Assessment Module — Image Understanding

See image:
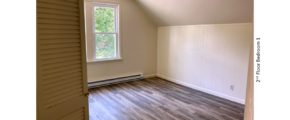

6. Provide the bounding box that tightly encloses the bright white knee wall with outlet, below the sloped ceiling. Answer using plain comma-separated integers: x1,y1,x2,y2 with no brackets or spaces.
157,23,253,104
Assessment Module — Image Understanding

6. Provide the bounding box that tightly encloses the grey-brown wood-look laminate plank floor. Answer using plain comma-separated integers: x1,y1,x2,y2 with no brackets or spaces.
89,78,244,120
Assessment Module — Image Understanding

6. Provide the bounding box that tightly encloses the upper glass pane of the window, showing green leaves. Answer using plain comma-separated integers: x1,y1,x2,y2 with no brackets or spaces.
95,7,115,32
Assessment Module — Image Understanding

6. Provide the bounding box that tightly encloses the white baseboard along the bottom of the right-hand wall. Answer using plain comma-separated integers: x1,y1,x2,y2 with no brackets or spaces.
156,74,245,105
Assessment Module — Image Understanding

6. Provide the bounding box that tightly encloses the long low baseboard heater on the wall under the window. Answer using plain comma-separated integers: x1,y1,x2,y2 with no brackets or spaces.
88,74,144,89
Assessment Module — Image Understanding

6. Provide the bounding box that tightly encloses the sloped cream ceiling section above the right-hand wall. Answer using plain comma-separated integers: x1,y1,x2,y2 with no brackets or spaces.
136,0,253,26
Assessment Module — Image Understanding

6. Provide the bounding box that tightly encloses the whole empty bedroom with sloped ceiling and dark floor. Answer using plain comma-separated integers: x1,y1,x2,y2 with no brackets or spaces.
37,0,253,120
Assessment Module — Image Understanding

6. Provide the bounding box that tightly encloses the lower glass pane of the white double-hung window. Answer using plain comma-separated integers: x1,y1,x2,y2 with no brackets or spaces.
96,34,117,59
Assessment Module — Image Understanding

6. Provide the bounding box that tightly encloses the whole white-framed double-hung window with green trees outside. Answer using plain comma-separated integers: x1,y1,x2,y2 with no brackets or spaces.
86,3,121,62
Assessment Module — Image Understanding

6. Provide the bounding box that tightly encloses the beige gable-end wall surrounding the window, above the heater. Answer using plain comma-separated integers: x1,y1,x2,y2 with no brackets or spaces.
87,0,157,82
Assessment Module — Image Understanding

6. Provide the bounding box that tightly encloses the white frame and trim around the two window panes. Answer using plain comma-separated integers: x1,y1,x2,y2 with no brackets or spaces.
86,2,122,62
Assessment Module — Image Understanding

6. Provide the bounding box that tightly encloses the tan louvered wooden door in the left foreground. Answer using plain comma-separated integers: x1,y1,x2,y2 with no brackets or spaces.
36,0,88,120
